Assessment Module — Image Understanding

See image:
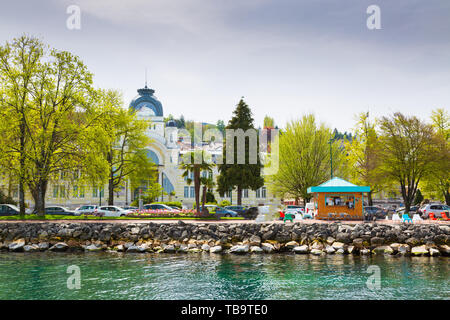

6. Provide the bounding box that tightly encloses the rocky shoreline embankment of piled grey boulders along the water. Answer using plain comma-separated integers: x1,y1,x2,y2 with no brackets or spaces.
0,221,450,256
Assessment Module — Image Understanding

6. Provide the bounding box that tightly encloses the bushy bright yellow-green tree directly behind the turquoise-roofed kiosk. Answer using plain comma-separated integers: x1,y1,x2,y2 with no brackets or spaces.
268,114,347,201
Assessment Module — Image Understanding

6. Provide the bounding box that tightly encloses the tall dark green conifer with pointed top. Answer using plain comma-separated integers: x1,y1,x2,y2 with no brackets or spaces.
217,98,264,205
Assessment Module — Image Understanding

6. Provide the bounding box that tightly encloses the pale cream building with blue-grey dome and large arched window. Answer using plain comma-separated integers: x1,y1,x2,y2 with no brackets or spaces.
15,84,279,209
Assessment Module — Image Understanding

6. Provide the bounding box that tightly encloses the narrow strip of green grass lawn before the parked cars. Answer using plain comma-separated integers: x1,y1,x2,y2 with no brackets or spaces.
0,214,244,221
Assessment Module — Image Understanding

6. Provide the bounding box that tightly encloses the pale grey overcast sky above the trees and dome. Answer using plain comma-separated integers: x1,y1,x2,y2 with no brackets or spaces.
0,0,450,131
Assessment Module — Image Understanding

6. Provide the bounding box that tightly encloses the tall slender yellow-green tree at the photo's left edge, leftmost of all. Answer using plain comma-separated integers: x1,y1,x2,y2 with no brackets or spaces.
0,36,44,216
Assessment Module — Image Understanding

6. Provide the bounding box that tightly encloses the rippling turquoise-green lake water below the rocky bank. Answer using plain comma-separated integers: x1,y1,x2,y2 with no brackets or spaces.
0,253,450,300
